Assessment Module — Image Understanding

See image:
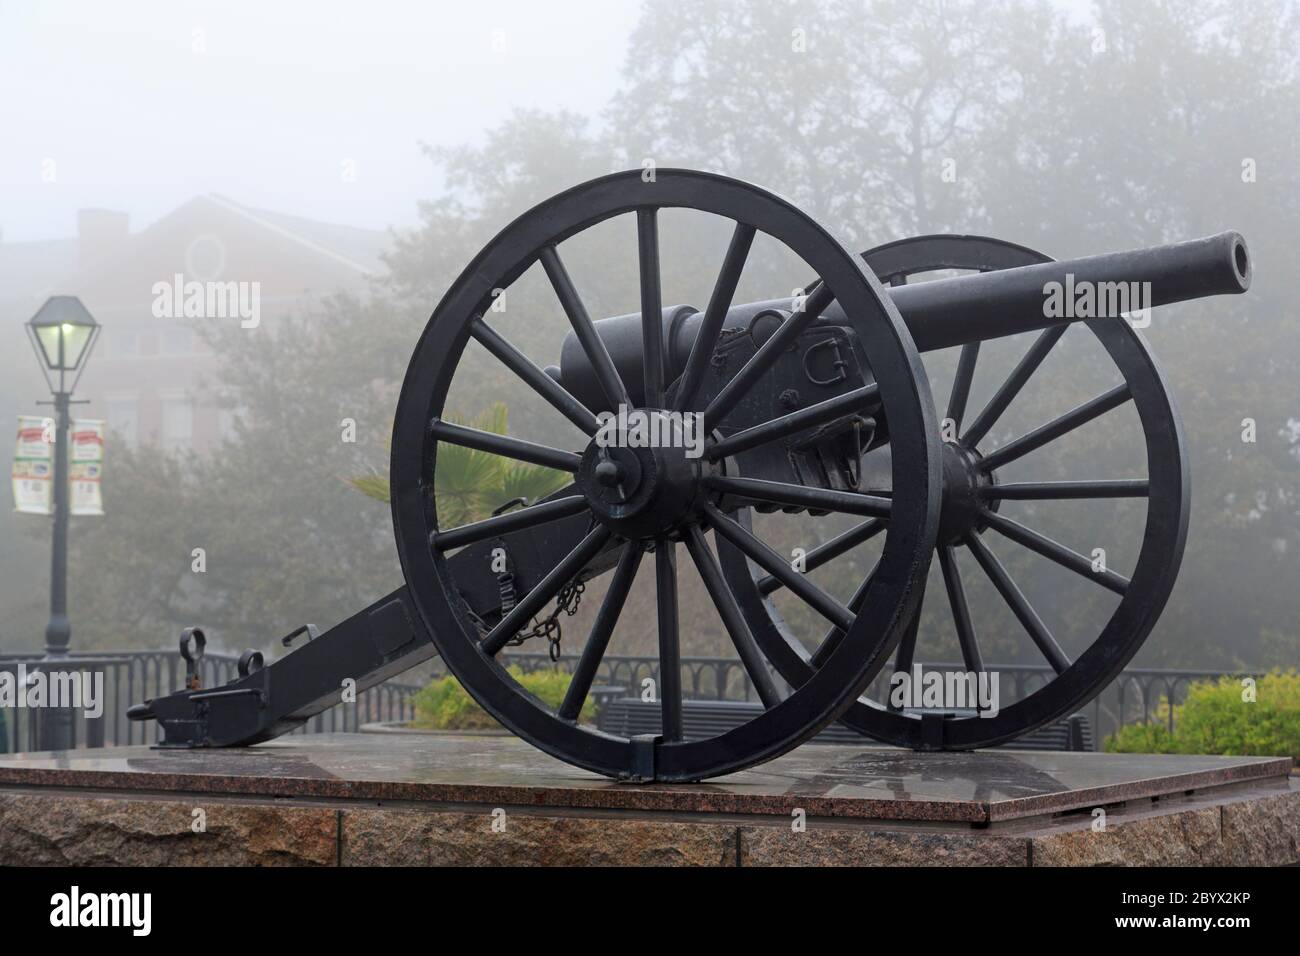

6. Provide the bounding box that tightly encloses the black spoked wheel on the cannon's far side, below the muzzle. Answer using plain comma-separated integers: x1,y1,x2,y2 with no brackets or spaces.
719,235,1190,750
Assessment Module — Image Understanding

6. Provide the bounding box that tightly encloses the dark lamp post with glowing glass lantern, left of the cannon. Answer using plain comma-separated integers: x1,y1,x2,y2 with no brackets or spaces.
27,295,100,750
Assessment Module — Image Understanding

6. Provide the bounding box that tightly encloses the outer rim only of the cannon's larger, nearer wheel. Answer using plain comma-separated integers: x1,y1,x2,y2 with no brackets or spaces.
390,169,939,780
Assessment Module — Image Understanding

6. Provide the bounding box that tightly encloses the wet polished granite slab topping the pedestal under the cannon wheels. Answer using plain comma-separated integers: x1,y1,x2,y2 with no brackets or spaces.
0,734,1291,823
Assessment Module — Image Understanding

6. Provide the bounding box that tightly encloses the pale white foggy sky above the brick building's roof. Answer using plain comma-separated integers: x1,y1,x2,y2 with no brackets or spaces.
0,0,640,242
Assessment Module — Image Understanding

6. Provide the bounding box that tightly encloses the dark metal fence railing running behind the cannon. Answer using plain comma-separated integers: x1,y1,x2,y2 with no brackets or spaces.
0,650,1255,753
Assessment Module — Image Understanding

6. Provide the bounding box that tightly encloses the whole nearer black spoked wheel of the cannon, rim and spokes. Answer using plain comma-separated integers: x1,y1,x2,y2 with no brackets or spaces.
390,169,940,780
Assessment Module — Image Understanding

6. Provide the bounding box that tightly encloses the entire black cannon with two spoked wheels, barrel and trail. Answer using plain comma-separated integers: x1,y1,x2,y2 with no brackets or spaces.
129,169,1251,780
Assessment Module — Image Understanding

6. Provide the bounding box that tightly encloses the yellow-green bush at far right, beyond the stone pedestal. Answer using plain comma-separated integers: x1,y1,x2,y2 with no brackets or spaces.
1106,670,1300,761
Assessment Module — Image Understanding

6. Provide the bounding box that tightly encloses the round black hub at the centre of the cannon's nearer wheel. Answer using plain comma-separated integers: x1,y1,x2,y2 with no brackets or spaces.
575,408,718,538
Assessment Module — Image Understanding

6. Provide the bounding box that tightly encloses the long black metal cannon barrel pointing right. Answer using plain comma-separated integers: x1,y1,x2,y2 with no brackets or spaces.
553,232,1251,408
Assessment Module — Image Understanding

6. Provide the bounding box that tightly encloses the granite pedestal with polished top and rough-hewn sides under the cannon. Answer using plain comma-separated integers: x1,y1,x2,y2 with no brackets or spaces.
0,734,1300,866
